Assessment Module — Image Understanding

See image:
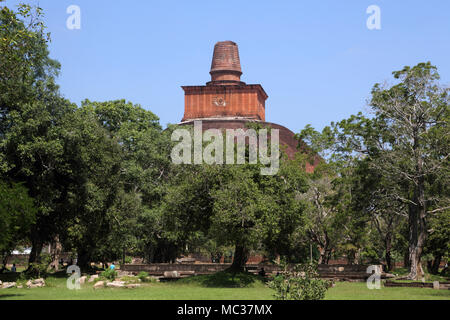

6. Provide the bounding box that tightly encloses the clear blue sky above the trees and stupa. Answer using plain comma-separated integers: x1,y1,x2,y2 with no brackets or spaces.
6,0,450,132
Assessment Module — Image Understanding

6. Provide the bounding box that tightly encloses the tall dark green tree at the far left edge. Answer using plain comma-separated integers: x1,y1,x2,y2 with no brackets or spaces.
0,1,75,263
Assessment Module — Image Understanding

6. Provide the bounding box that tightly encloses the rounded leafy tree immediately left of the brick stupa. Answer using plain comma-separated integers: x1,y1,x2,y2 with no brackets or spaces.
64,100,174,268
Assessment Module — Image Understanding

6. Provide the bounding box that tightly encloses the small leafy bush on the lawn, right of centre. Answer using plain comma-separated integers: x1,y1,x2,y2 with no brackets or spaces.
269,264,329,300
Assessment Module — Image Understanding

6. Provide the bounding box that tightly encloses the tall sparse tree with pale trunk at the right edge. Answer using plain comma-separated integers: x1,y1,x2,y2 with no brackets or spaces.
358,63,450,279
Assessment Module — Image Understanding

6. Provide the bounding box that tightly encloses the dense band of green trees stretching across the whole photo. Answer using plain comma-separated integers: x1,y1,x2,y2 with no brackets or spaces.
0,1,450,282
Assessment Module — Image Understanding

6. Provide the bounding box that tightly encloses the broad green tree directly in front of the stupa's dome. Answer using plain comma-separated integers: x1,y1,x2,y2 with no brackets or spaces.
163,144,306,271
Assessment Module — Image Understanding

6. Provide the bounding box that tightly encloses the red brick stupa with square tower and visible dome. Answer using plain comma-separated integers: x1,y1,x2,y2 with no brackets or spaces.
180,41,317,172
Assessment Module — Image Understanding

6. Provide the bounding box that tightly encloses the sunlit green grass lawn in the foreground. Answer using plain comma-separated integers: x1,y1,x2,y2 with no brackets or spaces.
0,273,450,300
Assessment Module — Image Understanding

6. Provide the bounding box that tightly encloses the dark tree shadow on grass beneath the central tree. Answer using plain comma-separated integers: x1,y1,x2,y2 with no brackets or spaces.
177,271,262,288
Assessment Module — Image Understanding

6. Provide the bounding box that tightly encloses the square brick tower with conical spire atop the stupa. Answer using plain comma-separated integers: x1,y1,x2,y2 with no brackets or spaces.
182,41,268,122
